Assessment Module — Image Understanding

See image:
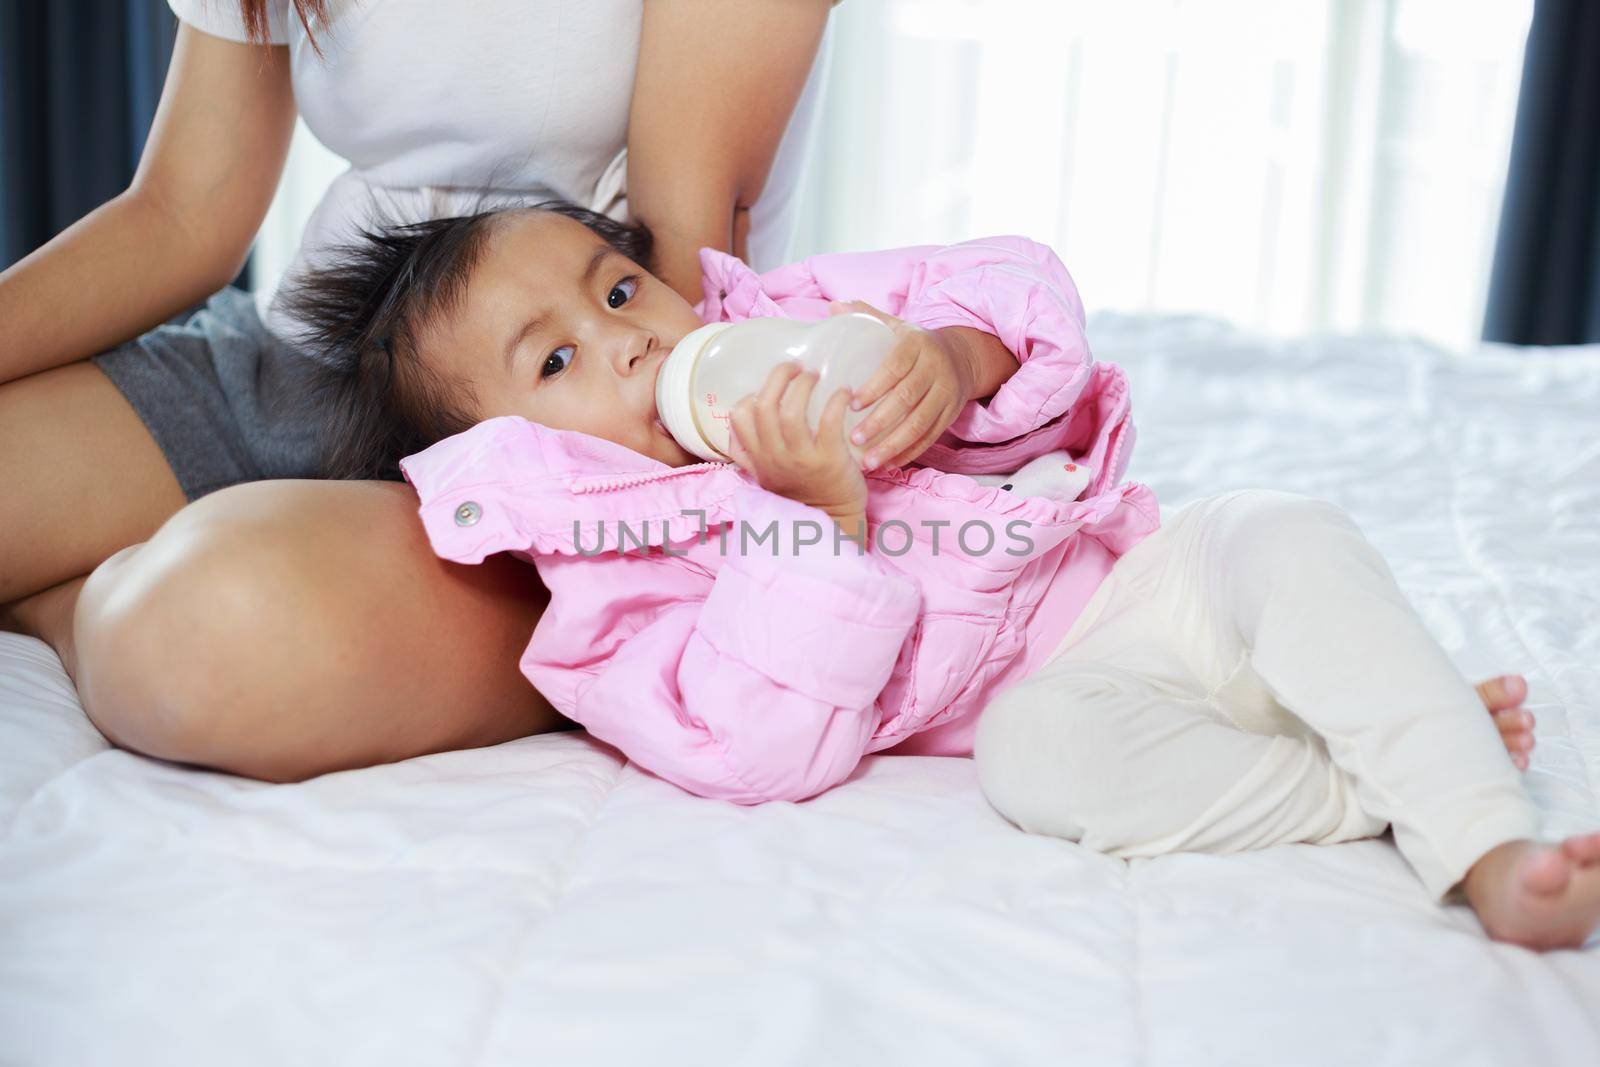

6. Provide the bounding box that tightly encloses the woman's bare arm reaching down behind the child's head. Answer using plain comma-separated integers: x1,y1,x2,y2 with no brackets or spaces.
627,0,834,302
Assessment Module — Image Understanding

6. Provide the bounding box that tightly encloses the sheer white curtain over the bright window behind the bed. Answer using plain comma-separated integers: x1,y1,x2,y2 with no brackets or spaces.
797,0,1531,346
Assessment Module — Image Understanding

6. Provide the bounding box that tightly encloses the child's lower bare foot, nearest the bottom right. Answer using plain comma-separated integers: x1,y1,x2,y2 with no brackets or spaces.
1462,833,1600,949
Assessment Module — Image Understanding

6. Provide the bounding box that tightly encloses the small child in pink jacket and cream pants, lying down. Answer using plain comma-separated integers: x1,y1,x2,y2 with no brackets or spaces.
293,202,1600,947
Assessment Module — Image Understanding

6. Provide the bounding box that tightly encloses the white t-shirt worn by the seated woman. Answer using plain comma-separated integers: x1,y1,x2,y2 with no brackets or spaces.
168,0,830,334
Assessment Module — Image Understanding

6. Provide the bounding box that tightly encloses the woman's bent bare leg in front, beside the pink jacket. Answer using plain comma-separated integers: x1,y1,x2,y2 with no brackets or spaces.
75,482,570,781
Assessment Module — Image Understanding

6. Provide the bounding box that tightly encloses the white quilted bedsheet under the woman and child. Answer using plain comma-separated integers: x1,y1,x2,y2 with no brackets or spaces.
0,315,1600,1067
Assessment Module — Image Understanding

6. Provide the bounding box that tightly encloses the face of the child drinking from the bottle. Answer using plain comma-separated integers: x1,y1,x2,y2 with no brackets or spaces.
422,211,701,467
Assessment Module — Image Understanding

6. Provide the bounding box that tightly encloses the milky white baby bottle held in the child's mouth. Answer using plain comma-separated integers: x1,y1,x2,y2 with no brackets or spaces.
656,312,894,461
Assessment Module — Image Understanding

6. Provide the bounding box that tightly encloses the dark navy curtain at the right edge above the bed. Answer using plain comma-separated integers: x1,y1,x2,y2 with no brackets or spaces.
1483,0,1600,344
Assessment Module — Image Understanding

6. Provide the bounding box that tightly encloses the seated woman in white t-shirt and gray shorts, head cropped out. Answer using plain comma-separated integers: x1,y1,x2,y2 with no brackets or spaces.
0,0,832,781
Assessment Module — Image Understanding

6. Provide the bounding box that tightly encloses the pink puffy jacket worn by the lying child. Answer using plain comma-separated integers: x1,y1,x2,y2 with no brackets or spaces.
402,237,1158,803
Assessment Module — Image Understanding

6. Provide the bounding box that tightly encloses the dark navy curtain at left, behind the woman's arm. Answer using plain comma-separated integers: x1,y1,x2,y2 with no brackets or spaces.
0,0,178,269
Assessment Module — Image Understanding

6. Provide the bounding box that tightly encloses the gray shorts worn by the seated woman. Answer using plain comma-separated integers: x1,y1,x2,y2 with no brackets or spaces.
93,288,320,501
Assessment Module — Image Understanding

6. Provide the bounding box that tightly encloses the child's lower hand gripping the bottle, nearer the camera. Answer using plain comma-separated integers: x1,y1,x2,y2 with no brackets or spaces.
728,362,867,537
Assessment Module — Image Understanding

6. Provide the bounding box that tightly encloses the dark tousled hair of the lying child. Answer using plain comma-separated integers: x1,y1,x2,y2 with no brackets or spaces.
283,200,654,482
